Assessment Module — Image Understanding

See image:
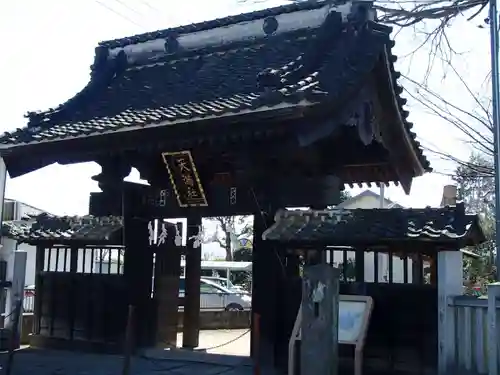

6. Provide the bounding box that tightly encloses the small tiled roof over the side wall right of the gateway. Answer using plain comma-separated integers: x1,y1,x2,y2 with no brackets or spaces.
263,204,484,246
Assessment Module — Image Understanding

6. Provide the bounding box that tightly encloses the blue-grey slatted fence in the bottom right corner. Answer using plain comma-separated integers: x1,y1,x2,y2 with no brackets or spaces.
447,285,500,375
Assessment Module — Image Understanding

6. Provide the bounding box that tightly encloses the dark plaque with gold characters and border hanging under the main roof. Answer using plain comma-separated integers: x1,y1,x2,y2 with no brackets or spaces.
162,151,208,207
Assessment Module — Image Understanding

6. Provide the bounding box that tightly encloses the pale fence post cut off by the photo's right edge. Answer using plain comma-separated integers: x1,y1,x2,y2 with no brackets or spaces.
487,282,500,375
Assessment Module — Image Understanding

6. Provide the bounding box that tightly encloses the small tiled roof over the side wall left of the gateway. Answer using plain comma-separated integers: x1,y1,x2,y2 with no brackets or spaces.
2,213,123,244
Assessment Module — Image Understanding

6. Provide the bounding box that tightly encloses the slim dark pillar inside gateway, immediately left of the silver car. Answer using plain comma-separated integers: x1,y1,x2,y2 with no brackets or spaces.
182,216,202,349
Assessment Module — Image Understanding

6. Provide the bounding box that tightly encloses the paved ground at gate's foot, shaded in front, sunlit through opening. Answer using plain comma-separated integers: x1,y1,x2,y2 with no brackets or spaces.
0,330,260,375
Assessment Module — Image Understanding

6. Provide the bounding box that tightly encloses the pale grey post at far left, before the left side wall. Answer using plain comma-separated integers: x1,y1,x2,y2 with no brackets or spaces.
5,251,28,346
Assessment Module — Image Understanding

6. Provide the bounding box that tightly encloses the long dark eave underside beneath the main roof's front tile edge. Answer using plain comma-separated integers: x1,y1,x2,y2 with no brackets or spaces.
0,108,302,177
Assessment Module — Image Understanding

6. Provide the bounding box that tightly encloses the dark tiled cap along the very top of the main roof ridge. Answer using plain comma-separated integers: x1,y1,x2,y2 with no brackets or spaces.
99,0,330,48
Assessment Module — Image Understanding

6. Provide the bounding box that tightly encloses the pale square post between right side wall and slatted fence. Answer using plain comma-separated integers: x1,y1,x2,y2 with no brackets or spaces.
437,250,463,375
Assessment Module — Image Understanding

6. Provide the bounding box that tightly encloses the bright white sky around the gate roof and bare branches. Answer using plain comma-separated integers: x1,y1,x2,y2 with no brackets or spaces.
0,0,490,215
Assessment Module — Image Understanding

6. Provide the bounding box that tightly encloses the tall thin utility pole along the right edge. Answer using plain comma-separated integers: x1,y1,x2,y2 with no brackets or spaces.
490,0,500,280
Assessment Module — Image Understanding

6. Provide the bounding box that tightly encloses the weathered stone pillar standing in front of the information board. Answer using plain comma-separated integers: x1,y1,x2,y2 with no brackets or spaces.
300,264,339,375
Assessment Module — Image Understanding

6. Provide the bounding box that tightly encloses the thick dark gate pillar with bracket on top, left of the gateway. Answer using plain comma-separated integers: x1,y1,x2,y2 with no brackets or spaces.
89,159,156,347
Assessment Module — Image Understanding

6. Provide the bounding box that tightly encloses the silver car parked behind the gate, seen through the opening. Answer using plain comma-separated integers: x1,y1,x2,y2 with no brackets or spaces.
179,278,252,311
